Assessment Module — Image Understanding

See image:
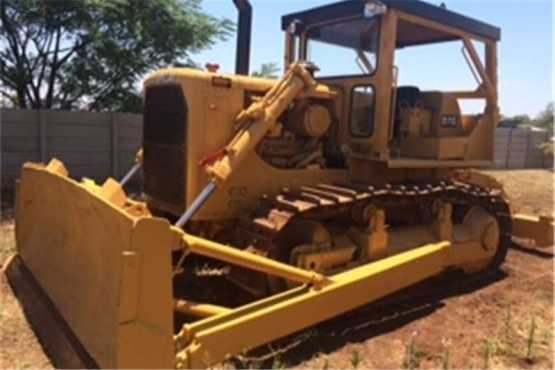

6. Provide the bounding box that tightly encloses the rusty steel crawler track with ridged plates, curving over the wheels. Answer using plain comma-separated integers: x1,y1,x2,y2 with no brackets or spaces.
239,180,511,265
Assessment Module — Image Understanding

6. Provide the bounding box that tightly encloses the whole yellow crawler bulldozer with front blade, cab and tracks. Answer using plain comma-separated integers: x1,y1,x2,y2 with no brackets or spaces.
4,0,553,368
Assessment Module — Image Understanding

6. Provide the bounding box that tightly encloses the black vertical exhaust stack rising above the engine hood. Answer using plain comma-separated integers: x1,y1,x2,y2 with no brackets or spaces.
233,0,252,75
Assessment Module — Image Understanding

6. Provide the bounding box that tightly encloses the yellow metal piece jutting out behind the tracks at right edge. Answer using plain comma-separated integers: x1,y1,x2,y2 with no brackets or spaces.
512,214,553,248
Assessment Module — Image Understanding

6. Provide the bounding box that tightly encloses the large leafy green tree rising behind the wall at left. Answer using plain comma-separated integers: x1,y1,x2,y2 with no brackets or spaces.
0,0,233,111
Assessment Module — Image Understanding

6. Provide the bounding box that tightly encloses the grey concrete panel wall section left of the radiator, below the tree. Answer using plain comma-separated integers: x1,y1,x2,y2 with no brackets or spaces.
0,109,142,189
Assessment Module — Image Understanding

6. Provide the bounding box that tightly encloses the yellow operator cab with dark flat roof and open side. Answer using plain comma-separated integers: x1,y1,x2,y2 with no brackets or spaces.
282,0,500,168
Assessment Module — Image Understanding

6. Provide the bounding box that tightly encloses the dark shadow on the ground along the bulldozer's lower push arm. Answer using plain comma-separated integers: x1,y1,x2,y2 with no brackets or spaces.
238,270,508,368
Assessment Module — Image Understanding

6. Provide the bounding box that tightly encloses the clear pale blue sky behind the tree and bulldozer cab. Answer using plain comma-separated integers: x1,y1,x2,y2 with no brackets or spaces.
193,0,554,116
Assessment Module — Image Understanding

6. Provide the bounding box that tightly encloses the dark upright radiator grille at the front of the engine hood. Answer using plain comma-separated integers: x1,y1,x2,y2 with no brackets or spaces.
143,84,187,206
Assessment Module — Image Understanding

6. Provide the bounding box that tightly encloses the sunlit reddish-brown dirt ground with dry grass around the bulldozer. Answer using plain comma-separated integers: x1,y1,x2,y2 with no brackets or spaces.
0,170,553,369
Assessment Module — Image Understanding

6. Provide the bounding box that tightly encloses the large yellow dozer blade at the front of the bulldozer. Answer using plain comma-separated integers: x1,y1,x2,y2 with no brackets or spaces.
2,160,180,368
